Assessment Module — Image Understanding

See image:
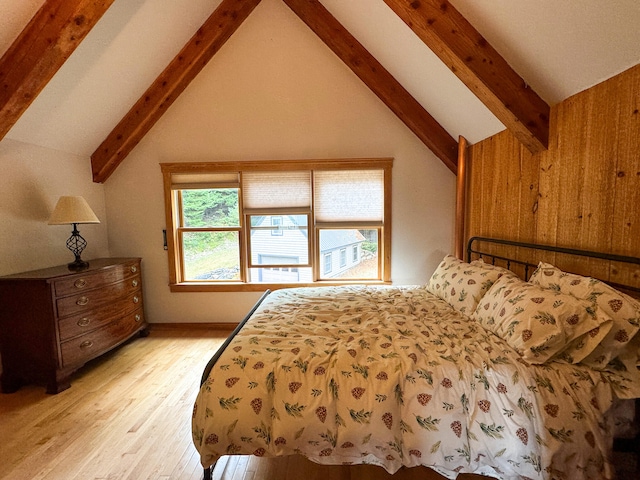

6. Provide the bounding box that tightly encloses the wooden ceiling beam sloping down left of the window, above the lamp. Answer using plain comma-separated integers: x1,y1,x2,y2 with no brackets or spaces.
91,0,260,182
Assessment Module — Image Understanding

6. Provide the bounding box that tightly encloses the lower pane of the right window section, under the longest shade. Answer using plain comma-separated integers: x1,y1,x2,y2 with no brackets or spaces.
320,229,379,280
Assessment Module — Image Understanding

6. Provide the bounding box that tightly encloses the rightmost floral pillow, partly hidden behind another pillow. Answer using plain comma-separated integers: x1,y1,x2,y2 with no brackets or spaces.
529,262,640,370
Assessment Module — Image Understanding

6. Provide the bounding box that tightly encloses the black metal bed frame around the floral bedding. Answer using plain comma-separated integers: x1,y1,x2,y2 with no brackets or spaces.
200,237,640,480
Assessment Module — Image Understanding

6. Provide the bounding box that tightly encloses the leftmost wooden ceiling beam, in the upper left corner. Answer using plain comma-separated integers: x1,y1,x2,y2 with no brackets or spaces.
0,0,113,140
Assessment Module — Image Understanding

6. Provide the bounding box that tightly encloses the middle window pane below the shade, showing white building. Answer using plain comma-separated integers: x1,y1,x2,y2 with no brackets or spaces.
249,215,309,265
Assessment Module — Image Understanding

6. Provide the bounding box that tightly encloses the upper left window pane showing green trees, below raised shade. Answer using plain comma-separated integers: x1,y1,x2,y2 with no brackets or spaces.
180,188,240,228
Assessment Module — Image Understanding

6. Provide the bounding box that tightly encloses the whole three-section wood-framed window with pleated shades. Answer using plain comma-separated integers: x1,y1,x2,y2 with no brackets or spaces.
161,159,392,291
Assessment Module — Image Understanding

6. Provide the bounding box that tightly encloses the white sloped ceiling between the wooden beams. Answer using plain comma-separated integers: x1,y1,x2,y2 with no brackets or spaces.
0,0,640,157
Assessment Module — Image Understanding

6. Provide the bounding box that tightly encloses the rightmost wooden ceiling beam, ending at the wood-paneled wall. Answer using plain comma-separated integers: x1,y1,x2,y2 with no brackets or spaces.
384,0,550,153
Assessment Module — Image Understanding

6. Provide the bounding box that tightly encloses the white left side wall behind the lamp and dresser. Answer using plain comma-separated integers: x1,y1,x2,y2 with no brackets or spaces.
0,138,109,275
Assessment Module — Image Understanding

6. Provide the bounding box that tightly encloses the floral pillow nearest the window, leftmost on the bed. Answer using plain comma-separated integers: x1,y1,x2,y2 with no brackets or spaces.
426,255,514,316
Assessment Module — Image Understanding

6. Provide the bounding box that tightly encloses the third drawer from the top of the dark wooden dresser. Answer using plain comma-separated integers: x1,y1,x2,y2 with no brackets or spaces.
59,291,142,342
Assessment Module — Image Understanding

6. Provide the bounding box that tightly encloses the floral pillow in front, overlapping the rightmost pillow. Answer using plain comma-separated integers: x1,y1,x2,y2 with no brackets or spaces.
473,276,610,364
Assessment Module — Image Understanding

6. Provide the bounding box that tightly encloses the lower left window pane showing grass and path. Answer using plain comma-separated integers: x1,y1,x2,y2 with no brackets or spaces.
182,232,240,281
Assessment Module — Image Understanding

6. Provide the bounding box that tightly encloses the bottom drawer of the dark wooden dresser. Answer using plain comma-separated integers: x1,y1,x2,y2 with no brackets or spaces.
60,309,144,367
